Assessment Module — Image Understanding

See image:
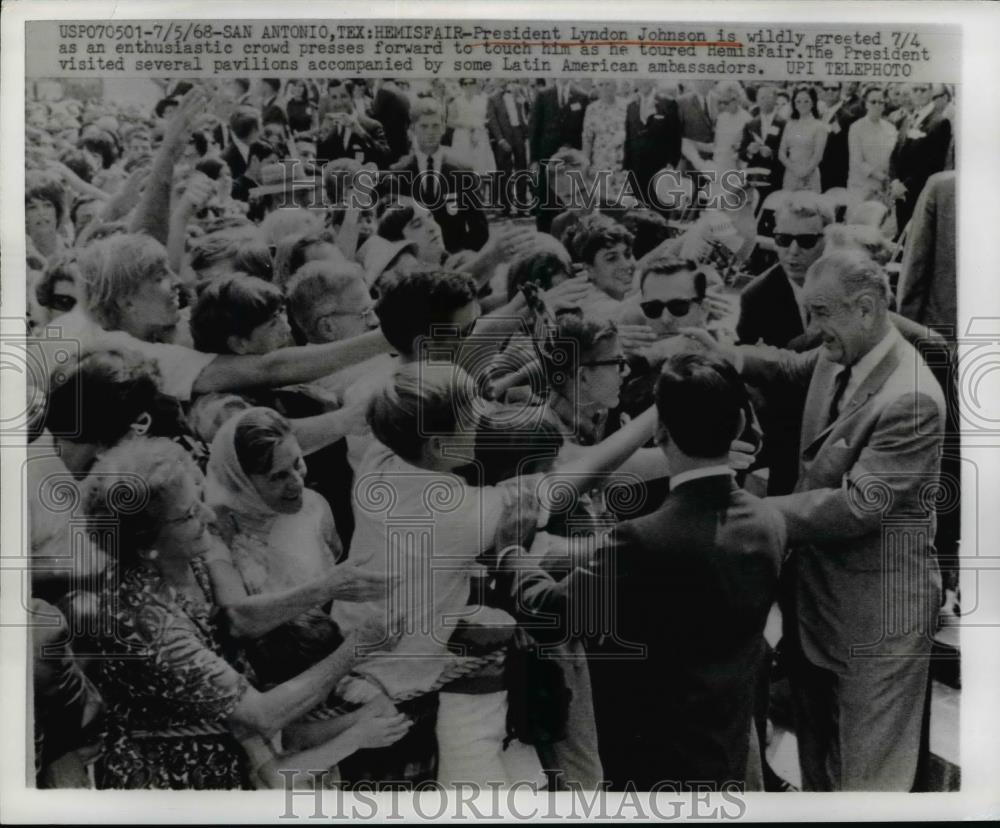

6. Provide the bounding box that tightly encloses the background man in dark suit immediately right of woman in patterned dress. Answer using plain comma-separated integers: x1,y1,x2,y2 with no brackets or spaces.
624,78,681,204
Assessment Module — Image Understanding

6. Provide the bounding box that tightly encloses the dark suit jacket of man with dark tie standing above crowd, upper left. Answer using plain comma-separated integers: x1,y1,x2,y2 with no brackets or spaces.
389,151,490,253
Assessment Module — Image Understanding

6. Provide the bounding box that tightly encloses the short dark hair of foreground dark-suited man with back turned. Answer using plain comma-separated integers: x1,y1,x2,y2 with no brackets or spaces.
655,354,749,458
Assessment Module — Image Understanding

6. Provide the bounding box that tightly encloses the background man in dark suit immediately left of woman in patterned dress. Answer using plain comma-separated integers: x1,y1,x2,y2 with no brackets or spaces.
528,79,590,233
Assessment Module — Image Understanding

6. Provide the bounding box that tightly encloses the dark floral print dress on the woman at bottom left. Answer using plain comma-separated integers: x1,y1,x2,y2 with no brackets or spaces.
95,561,253,790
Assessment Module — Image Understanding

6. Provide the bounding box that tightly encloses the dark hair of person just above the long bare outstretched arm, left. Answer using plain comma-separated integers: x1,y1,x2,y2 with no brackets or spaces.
191,273,285,354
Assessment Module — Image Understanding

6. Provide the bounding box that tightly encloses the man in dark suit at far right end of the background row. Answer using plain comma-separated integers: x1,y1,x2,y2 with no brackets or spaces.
889,83,951,232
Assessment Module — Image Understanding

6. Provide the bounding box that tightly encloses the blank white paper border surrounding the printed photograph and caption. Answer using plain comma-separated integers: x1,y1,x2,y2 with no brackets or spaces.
0,0,1000,824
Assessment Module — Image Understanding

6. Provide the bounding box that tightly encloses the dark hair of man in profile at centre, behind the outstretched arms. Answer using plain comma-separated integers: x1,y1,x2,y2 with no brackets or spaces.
375,270,477,355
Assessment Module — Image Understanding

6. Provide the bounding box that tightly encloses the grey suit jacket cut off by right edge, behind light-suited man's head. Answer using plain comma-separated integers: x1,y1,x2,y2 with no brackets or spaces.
896,171,958,339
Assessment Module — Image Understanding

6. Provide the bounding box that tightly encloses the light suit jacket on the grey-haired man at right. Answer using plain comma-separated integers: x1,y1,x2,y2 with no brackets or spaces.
742,334,945,675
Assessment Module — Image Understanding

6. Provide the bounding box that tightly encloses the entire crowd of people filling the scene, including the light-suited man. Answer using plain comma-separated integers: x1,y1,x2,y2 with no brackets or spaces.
25,78,957,791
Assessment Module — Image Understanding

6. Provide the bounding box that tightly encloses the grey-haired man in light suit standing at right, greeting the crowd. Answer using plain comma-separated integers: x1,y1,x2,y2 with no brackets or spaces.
706,251,945,791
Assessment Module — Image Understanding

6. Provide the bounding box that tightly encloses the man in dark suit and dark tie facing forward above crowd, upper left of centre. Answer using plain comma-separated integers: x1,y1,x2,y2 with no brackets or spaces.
389,98,489,253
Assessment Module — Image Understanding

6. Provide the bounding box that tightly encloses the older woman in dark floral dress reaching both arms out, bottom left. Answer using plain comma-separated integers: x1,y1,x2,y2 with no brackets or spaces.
83,439,406,789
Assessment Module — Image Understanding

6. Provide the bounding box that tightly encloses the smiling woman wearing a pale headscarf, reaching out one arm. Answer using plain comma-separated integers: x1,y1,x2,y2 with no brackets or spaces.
207,408,387,684
